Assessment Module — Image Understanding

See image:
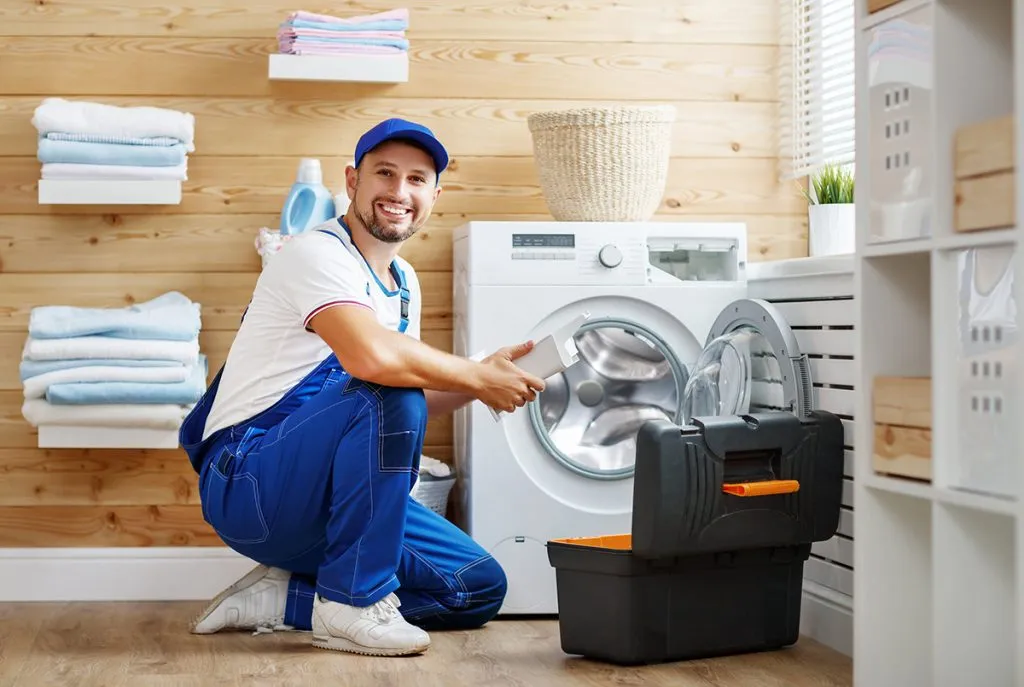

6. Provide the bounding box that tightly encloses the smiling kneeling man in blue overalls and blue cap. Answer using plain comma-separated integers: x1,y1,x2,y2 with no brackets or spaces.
180,119,544,655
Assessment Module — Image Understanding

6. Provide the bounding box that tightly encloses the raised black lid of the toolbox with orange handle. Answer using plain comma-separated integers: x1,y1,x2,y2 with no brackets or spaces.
632,411,844,558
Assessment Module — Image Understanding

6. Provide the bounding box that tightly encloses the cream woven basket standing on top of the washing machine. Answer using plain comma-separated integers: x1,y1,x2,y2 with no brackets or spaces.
526,105,676,222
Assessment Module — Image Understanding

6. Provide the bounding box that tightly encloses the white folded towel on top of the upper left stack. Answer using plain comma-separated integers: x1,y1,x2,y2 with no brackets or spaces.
32,98,196,153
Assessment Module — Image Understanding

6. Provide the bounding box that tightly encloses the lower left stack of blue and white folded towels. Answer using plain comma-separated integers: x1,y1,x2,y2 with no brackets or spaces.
19,292,209,436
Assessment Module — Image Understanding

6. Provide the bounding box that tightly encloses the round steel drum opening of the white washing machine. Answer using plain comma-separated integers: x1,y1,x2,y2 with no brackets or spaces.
529,317,687,479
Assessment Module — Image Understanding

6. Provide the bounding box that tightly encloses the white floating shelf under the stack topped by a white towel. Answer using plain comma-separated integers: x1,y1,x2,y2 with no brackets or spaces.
39,179,181,205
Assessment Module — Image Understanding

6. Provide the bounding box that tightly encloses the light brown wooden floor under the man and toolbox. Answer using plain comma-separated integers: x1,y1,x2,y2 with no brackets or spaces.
0,602,852,687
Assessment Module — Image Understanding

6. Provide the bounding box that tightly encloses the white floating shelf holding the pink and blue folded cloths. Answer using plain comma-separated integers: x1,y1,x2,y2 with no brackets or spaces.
269,52,409,84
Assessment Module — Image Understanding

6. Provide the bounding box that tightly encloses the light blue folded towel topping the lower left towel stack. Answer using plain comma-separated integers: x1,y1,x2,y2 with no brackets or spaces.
29,291,202,341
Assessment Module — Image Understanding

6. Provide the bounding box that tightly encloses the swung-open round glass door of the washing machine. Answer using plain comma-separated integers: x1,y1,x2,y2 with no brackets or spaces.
682,299,811,424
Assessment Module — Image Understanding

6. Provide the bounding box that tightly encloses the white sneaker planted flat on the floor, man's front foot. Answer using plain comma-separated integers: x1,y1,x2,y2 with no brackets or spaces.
313,594,430,656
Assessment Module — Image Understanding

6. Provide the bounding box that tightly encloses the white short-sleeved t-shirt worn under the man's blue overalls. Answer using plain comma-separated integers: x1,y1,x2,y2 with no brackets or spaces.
203,219,422,438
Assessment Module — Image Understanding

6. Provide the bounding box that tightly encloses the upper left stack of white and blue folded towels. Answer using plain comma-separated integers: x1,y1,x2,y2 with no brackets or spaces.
32,98,196,181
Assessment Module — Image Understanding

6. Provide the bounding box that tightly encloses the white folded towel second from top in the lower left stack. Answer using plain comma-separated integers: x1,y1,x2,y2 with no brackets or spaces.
22,336,199,366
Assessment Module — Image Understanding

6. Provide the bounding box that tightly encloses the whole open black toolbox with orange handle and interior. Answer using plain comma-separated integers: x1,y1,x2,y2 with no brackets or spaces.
547,411,844,664
